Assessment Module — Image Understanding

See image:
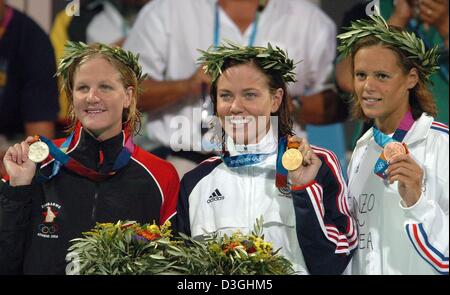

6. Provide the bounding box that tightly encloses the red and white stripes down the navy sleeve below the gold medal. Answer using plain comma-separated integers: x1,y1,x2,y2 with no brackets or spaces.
313,146,357,247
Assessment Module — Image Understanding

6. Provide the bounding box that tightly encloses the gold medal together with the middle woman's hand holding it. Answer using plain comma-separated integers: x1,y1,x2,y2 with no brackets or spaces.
281,136,322,186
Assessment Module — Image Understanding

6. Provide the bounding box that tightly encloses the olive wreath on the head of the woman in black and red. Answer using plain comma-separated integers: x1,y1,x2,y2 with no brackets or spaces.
56,41,147,83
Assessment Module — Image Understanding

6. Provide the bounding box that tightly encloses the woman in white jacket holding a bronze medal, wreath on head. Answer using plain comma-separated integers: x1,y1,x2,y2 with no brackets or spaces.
338,16,449,274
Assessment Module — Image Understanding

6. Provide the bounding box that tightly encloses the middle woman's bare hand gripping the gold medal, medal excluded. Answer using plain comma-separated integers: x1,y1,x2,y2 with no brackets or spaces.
289,136,322,186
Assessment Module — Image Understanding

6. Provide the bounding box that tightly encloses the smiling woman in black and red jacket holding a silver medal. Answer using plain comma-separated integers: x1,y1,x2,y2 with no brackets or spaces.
0,42,179,274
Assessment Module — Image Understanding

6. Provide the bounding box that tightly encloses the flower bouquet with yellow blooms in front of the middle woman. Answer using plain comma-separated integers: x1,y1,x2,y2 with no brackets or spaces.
168,218,294,275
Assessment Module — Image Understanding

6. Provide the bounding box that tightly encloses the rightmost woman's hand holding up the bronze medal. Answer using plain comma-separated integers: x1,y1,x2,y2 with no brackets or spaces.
386,154,423,207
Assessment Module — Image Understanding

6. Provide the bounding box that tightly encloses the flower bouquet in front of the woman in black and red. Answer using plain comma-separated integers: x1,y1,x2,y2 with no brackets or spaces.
66,221,178,275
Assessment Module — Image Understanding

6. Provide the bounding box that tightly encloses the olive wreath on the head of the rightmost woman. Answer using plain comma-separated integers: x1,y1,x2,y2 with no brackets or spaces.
337,14,439,81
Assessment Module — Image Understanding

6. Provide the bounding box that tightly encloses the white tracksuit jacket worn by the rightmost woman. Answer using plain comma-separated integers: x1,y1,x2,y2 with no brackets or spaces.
348,114,449,275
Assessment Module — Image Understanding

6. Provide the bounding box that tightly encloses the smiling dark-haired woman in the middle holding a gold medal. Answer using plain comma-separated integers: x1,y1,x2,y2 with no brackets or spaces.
177,43,357,274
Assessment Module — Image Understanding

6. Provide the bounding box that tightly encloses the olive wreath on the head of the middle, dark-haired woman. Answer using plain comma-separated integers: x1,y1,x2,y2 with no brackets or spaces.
198,42,296,83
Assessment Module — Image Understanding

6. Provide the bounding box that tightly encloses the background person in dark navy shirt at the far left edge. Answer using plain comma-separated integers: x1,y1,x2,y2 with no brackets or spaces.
0,0,58,176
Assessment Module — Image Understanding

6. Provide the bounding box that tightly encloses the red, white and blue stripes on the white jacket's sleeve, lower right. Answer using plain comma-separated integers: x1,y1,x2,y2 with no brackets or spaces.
405,224,448,275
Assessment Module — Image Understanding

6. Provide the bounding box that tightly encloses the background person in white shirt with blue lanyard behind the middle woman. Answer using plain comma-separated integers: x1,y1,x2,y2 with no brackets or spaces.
124,0,346,175
